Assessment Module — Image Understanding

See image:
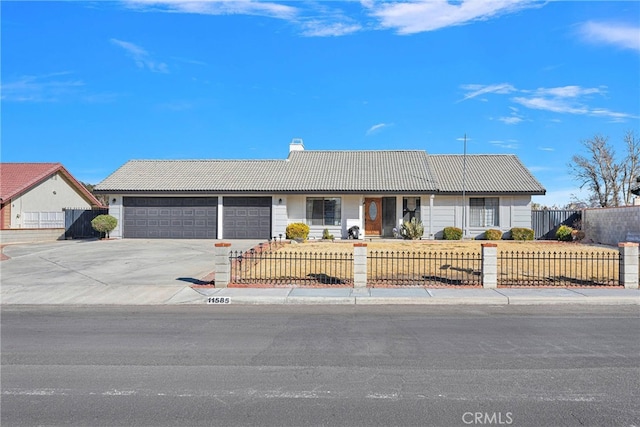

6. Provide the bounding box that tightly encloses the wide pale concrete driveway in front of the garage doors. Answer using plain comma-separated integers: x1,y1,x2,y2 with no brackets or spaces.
0,239,259,289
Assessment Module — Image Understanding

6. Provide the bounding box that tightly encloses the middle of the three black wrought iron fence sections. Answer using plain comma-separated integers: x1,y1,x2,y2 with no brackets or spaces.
367,251,482,287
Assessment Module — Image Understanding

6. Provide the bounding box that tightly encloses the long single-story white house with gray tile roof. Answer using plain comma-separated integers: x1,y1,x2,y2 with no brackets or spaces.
95,140,545,240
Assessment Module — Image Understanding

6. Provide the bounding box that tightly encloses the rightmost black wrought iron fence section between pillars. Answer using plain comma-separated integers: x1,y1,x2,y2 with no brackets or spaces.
498,251,621,286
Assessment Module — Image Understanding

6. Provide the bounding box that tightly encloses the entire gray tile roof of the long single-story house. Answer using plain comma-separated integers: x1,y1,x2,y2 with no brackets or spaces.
96,150,544,194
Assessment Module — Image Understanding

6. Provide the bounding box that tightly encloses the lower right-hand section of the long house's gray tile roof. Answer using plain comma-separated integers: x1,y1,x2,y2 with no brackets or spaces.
429,154,545,194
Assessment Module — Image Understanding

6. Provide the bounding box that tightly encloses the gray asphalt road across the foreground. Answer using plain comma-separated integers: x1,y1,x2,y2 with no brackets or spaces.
0,306,640,426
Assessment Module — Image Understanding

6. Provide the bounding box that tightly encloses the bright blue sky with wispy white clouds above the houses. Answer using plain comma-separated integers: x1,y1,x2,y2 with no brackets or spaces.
0,0,640,206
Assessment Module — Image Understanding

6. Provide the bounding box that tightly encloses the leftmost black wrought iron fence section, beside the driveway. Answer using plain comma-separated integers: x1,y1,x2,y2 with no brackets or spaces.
230,250,353,286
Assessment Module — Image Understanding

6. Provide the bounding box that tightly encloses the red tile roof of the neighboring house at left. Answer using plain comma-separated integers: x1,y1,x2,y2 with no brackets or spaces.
0,163,101,206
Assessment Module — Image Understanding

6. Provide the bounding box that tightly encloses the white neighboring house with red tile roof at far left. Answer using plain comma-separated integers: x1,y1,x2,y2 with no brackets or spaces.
0,163,102,230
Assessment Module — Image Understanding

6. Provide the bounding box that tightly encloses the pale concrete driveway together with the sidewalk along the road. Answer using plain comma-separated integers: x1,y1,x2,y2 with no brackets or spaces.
0,239,640,305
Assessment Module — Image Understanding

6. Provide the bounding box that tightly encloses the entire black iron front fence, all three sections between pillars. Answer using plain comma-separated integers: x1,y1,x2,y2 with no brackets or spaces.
229,247,622,287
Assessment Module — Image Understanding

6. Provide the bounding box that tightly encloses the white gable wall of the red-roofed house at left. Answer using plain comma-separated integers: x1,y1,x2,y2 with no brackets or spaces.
11,173,91,228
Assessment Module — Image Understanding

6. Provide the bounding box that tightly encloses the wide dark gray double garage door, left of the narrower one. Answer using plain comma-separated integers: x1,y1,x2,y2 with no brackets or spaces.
123,197,218,239
